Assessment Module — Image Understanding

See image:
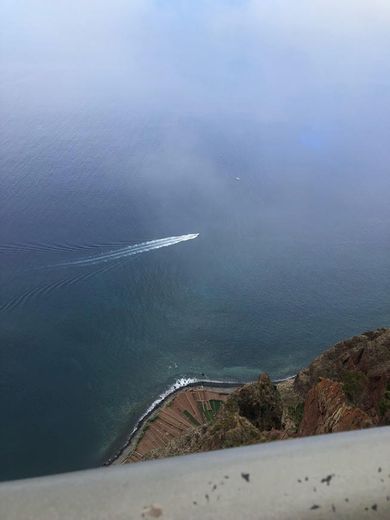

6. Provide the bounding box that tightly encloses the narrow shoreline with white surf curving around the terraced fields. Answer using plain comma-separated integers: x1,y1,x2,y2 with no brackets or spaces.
102,374,296,466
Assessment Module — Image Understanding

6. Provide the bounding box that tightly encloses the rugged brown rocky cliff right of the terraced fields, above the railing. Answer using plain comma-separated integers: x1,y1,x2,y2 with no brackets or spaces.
144,329,390,458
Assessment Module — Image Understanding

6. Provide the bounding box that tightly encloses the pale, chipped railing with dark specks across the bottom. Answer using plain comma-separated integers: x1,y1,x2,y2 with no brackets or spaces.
0,427,390,520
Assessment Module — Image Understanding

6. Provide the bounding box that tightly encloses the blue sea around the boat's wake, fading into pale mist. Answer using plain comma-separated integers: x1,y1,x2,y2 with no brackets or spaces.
0,0,390,479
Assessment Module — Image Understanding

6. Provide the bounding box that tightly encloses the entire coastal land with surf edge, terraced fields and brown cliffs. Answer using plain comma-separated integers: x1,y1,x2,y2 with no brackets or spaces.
105,328,390,465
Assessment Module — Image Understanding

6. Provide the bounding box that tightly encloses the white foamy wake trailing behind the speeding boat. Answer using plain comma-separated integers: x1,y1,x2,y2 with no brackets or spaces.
53,233,199,267
